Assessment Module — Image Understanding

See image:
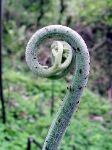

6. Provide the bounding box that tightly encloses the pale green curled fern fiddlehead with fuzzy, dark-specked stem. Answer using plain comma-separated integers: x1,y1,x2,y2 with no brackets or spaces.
26,25,90,150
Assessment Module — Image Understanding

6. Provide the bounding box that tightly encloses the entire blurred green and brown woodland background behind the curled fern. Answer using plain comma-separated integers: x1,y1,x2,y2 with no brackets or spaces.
0,0,112,150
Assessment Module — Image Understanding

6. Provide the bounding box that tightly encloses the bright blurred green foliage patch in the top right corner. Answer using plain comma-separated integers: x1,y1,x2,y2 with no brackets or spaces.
69,0,112,26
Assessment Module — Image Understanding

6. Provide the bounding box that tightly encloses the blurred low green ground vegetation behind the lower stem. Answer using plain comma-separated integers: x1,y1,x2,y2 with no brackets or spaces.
0,58,112,150
